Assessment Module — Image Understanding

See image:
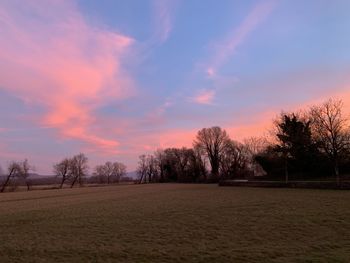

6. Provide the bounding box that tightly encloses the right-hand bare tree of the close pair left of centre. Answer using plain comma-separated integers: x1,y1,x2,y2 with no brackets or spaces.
70,153,89,188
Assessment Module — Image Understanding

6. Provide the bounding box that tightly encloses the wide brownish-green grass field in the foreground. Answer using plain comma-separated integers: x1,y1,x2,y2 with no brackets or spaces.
0,184,350,262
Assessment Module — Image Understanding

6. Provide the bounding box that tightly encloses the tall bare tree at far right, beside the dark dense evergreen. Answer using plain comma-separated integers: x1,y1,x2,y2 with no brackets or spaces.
310,99,350,184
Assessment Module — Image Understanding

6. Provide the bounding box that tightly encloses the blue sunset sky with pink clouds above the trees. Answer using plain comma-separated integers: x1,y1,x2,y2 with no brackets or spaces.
0,0,350,174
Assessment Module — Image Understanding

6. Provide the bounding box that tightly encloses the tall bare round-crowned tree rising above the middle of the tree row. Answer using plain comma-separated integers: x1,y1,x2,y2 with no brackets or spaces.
193,127,230,180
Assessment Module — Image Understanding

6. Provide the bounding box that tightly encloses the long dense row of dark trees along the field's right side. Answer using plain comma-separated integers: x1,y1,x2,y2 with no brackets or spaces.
137,99,350,183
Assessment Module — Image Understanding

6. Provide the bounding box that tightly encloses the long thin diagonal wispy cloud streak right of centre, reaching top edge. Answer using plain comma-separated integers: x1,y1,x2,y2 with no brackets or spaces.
205,0,277,77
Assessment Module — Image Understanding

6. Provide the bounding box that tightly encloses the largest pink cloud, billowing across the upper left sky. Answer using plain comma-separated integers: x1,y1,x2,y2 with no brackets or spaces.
0,0,135,152
